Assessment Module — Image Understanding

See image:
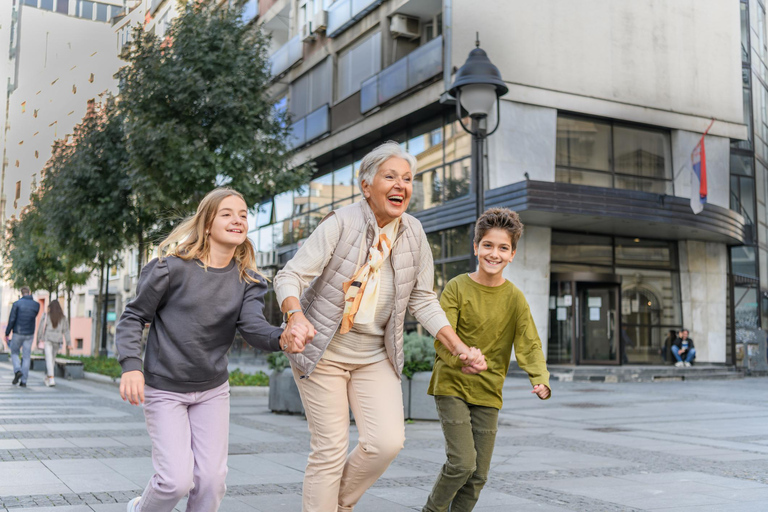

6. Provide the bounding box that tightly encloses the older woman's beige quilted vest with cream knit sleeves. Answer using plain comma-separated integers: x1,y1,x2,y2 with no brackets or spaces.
274,200,450,377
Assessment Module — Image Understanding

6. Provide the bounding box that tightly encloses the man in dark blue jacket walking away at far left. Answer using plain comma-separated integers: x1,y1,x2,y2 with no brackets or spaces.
5,286,40,388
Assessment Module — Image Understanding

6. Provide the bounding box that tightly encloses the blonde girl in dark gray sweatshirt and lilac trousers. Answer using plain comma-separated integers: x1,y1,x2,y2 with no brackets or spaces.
115,188,307,512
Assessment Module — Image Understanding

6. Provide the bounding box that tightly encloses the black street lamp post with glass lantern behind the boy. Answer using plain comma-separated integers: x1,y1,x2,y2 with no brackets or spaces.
448,37,509,218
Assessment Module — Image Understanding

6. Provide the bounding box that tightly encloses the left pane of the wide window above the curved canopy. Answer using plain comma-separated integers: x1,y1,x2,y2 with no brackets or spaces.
556,116,611,171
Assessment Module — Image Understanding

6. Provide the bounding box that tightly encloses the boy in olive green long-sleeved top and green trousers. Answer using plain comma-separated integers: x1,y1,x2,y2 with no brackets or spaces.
422,208,550,512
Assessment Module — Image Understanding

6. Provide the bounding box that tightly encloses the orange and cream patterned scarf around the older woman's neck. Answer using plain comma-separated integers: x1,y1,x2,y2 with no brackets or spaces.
339,218,400,334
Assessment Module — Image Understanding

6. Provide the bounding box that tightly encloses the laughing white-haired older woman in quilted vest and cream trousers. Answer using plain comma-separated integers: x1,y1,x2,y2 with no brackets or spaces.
274,142,486,512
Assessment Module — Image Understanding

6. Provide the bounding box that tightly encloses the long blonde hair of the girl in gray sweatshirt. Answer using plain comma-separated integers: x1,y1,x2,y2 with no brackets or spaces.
157,187,261,283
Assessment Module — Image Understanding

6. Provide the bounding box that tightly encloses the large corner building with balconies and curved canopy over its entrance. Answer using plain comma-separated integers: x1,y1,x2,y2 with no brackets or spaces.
250,0,752,364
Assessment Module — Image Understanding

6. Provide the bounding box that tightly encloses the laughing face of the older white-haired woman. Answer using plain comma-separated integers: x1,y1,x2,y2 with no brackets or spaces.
362,157,413,227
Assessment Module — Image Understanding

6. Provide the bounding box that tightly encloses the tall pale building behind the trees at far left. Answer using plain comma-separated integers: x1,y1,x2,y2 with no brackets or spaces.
0,0,123,353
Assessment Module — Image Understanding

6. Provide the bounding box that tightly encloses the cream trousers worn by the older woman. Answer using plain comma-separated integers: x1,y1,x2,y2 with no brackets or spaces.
293,359,405,512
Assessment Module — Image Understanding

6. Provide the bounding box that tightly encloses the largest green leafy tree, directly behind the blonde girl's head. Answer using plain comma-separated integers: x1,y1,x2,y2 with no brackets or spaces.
119,2,310,262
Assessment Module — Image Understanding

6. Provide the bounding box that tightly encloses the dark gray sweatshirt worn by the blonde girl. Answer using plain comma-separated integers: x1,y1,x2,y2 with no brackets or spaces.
115,256,282,393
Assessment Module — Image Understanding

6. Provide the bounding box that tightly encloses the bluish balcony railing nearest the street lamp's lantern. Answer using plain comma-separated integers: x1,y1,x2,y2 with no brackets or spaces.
360,36,443,112
